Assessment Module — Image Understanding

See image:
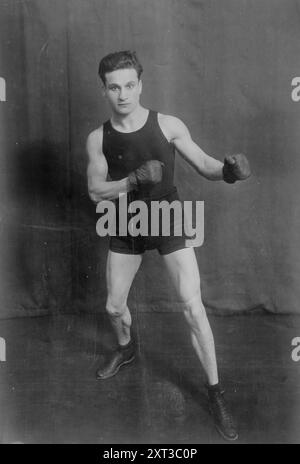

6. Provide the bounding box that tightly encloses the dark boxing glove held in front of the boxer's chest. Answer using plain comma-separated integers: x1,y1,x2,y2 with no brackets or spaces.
128,160,164,189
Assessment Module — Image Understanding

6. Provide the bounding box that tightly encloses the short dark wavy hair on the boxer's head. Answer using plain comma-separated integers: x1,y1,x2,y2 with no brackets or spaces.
98,50,143,84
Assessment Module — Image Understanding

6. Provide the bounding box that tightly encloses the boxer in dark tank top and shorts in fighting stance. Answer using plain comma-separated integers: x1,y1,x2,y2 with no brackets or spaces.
87,51,250,440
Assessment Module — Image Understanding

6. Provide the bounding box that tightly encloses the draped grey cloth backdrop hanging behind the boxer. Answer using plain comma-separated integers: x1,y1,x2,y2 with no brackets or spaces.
0,0,300,318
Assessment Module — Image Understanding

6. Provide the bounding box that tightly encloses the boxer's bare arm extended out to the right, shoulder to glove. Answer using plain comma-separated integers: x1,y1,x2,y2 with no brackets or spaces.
161,116,223,180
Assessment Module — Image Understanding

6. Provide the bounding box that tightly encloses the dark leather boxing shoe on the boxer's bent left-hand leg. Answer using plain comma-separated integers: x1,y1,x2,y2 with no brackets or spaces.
96,341,135,380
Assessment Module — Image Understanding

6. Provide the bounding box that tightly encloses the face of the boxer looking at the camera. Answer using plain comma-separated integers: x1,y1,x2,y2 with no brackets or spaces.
104,69,142,115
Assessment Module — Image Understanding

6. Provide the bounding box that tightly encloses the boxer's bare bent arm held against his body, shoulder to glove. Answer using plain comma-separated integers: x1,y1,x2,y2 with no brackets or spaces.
86,129,130,203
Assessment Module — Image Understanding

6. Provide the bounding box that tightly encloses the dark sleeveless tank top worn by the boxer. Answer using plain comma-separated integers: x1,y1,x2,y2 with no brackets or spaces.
102,110,176,200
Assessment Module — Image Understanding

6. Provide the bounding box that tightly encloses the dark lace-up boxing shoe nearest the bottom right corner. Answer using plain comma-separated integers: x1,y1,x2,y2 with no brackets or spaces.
207,387,238,441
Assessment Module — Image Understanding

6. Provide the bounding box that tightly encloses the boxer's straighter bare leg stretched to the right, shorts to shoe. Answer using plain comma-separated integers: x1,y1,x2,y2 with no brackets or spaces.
163,248,218,385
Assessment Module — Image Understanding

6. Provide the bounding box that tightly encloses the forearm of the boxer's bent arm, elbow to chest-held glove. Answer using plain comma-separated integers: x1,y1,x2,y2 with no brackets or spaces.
89,177,131,203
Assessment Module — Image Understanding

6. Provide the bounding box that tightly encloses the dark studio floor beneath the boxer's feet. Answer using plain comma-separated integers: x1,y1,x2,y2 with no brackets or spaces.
0,312,300,444
